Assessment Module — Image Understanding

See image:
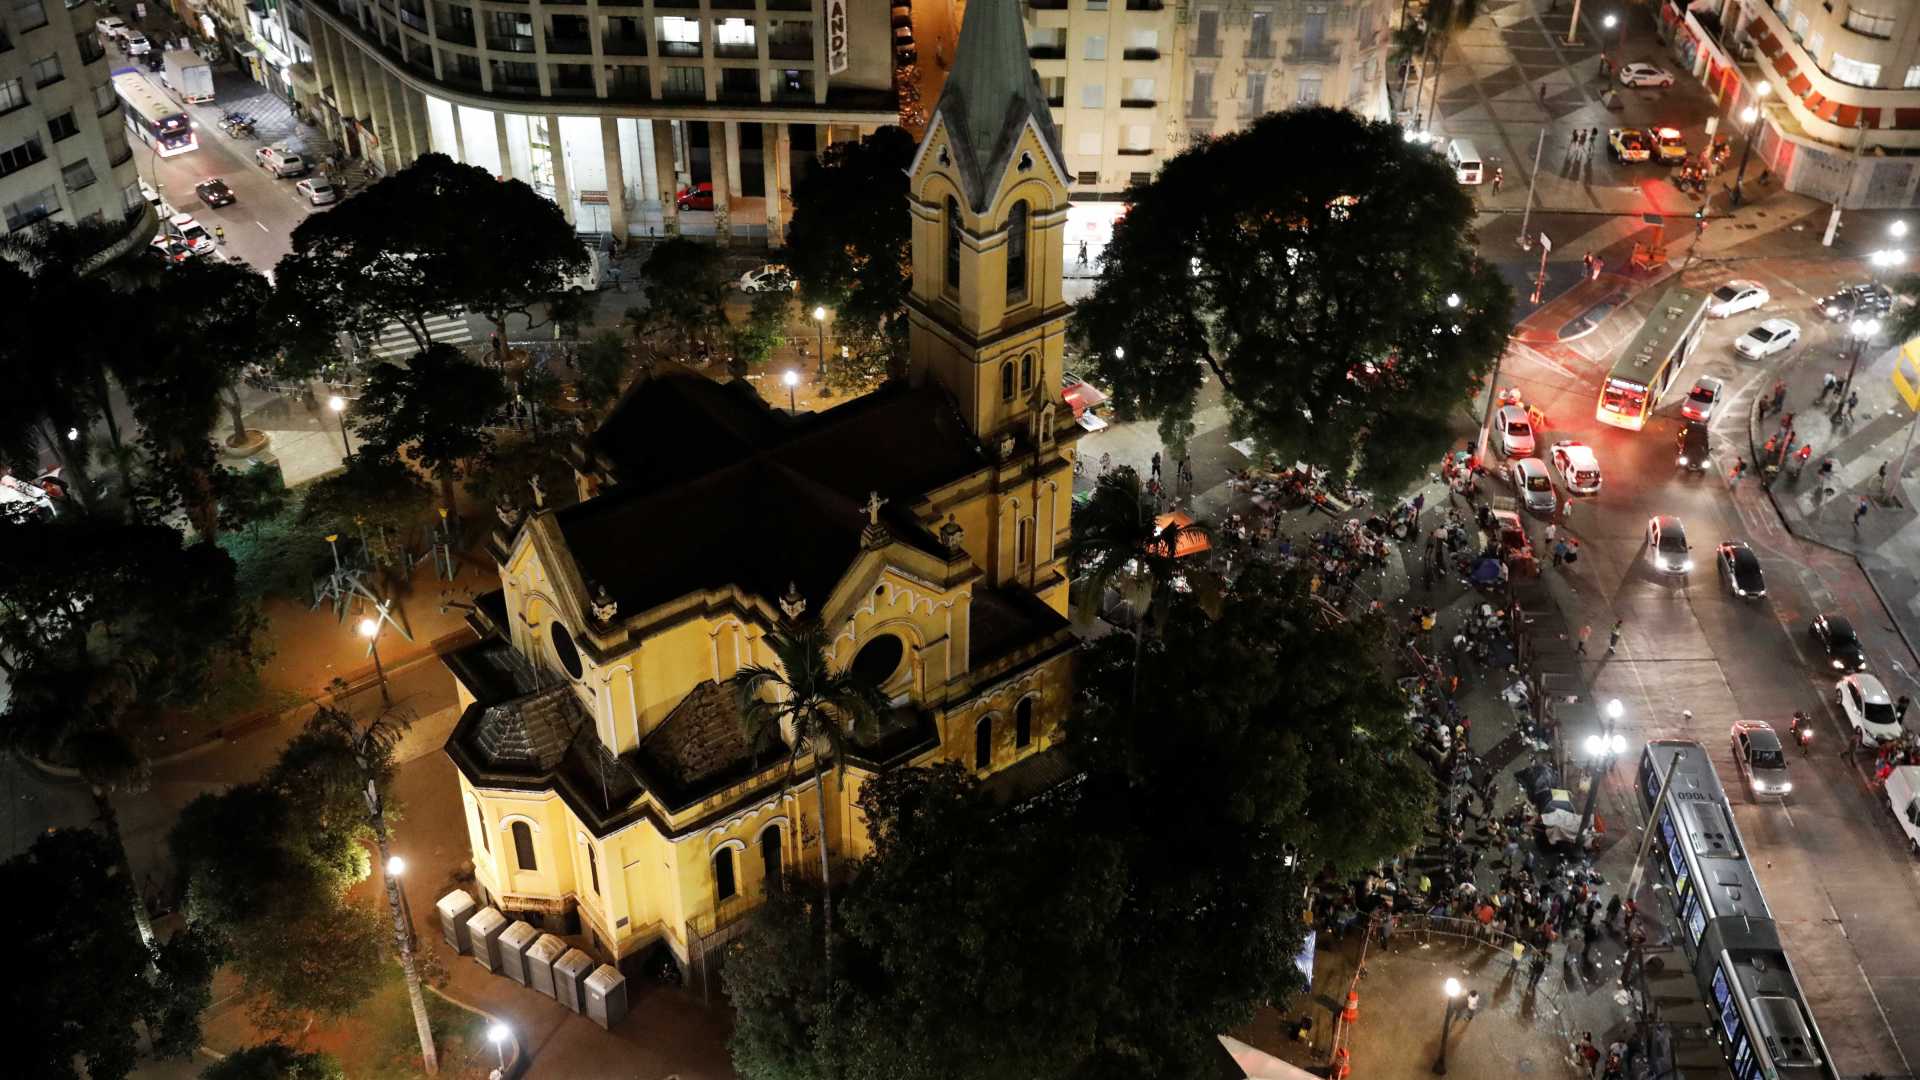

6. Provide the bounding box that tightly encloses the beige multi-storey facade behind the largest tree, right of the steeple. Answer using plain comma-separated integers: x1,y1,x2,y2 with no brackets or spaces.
1027,0,1394,273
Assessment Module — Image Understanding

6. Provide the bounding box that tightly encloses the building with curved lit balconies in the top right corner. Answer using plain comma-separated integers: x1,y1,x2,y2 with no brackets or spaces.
1689,0,1920,208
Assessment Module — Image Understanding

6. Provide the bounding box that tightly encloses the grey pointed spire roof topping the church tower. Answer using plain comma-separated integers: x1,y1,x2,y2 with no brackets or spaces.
929,0,1064,211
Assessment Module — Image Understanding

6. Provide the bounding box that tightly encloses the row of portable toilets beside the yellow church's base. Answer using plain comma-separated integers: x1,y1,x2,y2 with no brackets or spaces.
438,890,626,1028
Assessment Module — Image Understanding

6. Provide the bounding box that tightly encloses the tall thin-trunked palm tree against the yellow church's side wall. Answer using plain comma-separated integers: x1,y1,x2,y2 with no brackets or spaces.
728,621,887,970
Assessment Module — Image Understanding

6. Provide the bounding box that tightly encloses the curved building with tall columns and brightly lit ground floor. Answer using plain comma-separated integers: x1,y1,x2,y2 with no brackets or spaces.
305,0,899,246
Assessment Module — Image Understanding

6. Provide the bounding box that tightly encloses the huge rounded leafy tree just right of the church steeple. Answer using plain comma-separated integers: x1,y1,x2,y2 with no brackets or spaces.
1073,108,1511,486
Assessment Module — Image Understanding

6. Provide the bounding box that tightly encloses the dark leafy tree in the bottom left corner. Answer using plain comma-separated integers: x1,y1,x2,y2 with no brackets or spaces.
0,828,217,1080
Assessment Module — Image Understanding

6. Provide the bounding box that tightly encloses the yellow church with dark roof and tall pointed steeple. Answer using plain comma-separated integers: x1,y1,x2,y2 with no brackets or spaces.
447,0,1079,965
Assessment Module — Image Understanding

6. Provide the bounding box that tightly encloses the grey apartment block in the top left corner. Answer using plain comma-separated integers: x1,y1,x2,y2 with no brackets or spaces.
0,0,154,258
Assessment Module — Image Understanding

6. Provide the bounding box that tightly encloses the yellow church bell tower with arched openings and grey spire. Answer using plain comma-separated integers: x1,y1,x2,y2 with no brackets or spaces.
908,0,1068,444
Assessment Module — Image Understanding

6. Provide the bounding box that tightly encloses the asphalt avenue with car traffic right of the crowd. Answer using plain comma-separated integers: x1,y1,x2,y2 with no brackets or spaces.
1501,259,1920,1074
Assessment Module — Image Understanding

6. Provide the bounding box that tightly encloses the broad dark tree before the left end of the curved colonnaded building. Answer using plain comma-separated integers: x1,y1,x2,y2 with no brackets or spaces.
275,154,588,350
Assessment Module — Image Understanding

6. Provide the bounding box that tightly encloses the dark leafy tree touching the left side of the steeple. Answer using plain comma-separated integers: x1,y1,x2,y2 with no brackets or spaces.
787,125,914,346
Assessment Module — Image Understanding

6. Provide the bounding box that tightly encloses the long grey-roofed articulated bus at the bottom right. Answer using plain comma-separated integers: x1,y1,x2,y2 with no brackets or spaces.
1638,740,1839,1080
